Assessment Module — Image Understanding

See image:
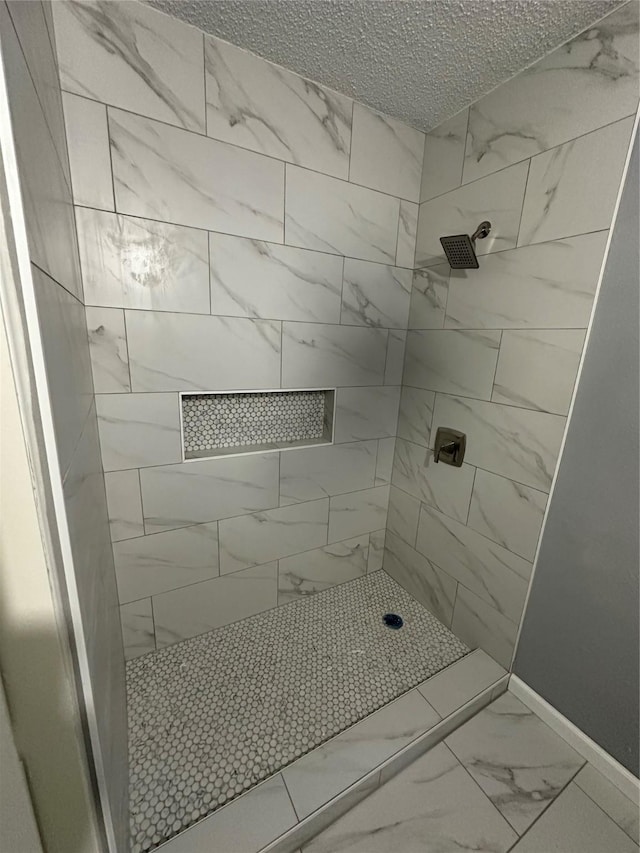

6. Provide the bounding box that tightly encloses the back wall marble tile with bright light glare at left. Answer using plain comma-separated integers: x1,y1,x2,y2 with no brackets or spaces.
76,207,209,314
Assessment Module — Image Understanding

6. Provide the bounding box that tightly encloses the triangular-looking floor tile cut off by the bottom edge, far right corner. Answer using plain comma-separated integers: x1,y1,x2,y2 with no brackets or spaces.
513,784,638,853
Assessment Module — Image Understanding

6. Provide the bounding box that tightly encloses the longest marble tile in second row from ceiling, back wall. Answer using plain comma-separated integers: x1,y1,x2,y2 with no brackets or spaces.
109,109,284,242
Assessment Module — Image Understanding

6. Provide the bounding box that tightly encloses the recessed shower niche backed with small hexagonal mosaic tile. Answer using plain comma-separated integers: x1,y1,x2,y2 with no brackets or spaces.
180,389,335,460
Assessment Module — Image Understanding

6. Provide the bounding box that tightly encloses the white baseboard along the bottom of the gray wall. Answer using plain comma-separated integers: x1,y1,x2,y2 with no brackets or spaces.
509,675,640,803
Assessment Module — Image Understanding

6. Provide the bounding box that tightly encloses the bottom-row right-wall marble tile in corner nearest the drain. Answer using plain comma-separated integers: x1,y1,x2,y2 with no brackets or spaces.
384,530,458,625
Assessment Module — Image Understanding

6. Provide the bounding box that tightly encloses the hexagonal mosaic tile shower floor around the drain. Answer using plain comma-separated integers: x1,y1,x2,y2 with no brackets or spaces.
127,571,469,853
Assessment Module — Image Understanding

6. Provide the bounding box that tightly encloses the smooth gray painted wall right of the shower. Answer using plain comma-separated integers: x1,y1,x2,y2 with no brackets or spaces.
515,130,640,776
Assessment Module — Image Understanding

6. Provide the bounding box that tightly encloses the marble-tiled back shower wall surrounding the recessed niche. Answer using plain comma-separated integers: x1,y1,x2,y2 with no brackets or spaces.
54,0,424,657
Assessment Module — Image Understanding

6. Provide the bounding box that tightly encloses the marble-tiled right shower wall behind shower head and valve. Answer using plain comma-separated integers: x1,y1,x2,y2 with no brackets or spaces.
384,3,639,667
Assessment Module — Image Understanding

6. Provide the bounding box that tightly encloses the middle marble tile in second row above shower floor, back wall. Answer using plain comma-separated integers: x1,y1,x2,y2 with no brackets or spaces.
219,498,330,575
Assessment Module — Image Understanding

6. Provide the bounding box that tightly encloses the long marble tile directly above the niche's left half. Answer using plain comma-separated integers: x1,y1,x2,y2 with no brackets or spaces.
125,311,282,391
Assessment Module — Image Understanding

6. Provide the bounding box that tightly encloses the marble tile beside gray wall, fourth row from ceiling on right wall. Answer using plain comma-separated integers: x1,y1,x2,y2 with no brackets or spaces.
491,329,585,415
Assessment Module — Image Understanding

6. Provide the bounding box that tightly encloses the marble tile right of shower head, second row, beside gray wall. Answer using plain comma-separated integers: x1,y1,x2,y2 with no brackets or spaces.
518,116,634,246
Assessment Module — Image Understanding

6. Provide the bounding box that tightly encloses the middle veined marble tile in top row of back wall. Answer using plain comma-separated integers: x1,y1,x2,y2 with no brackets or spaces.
205,36,353,178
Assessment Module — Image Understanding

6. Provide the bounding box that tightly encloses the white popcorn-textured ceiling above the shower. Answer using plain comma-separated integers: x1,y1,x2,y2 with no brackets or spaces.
147,0,620,130
